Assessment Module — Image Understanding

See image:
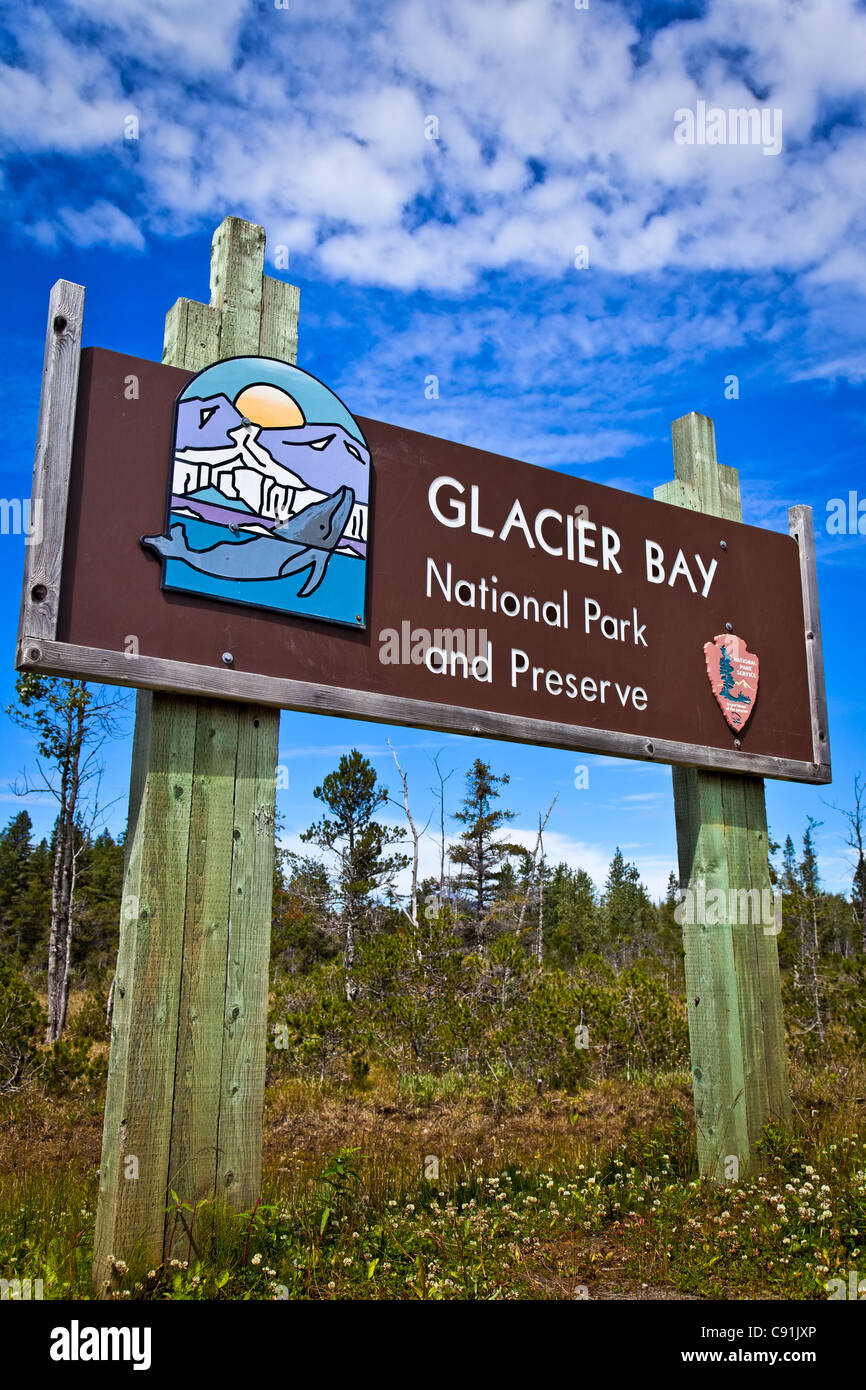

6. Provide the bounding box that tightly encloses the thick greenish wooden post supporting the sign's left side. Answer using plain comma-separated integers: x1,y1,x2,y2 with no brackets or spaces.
93,217,299,1290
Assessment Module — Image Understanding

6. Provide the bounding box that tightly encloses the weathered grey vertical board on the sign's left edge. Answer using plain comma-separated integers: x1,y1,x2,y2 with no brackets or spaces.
18,279,85,650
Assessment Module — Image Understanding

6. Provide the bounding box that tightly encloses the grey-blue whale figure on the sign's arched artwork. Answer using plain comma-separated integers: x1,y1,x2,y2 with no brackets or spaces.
140,487,354,598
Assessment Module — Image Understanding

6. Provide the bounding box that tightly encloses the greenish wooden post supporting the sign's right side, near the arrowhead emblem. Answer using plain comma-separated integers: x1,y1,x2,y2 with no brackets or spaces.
655,411,791,1182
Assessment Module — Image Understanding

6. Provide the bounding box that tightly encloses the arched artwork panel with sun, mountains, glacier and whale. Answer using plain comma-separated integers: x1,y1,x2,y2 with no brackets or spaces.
140,357,370,627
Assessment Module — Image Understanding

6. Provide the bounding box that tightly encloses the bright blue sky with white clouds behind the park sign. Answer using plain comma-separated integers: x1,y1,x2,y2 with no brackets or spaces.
0,0,866,894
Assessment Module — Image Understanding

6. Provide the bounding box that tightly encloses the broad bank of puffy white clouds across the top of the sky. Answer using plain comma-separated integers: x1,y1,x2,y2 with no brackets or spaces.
4,0,866,328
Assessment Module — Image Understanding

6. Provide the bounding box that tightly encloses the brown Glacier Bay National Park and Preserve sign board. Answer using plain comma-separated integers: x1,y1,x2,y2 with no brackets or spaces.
18,348,830,783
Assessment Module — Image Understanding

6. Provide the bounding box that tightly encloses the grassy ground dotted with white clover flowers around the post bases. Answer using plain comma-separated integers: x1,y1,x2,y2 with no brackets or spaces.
0,1062,866,1300
